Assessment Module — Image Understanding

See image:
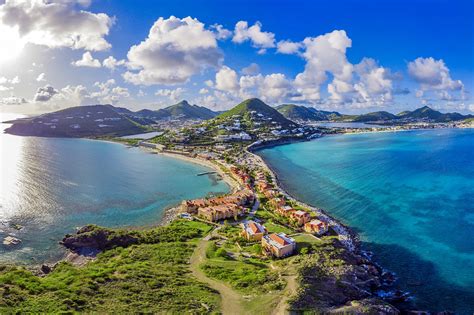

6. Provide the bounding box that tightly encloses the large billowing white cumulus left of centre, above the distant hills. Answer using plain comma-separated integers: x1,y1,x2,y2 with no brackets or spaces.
124,16,223,85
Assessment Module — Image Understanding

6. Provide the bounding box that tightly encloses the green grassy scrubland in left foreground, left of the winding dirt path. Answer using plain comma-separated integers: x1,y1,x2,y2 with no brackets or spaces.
0,221,220,314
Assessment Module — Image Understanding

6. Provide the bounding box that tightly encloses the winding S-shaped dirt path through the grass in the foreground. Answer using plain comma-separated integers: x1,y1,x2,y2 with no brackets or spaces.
190,239,244,315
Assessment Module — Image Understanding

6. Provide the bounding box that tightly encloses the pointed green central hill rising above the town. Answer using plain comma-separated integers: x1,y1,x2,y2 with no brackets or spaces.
216,98,297,128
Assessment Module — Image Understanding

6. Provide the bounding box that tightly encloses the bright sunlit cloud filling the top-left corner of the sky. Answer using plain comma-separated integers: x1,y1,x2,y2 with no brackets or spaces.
0,0,113,50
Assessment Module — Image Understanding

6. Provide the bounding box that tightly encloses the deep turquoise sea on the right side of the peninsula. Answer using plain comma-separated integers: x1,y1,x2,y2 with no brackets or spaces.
259,129,474,314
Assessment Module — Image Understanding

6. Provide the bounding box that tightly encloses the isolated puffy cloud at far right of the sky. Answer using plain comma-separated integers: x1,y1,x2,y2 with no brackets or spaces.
408,57,464,100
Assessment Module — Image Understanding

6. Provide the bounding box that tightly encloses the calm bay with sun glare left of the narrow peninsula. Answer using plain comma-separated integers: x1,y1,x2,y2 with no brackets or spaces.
0,117,229,263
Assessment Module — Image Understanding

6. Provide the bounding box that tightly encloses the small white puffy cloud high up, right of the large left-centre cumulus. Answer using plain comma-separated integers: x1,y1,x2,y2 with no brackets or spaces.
232,21,275,49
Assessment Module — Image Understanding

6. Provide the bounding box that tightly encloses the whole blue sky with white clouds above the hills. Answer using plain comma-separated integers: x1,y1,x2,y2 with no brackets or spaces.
0,0,474,114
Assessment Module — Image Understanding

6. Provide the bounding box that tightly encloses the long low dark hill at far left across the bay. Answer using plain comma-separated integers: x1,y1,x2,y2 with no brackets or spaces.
5,105,149,137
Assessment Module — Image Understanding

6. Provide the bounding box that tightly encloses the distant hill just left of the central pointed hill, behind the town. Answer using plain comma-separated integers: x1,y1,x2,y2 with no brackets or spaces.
135,100,217,120
